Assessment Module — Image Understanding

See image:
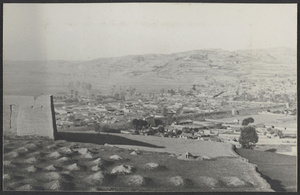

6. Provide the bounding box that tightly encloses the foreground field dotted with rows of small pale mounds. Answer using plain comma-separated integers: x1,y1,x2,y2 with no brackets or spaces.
3,134,272,192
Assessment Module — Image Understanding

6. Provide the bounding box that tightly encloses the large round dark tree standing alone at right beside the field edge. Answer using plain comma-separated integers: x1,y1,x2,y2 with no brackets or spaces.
239,126,258,149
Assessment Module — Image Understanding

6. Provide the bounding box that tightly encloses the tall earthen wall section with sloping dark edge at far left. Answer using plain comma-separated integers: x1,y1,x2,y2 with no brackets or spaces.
3,95,57,139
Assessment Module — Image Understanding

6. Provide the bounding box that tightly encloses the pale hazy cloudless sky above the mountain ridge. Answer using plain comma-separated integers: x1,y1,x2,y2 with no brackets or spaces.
3,3,297,60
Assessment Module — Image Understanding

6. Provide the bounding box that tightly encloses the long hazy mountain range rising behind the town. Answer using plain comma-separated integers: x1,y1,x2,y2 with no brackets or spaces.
3,48,297,94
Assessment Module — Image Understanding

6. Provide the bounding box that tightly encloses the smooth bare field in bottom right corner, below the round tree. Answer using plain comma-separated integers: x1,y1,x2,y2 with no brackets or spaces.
236,149,297,192
